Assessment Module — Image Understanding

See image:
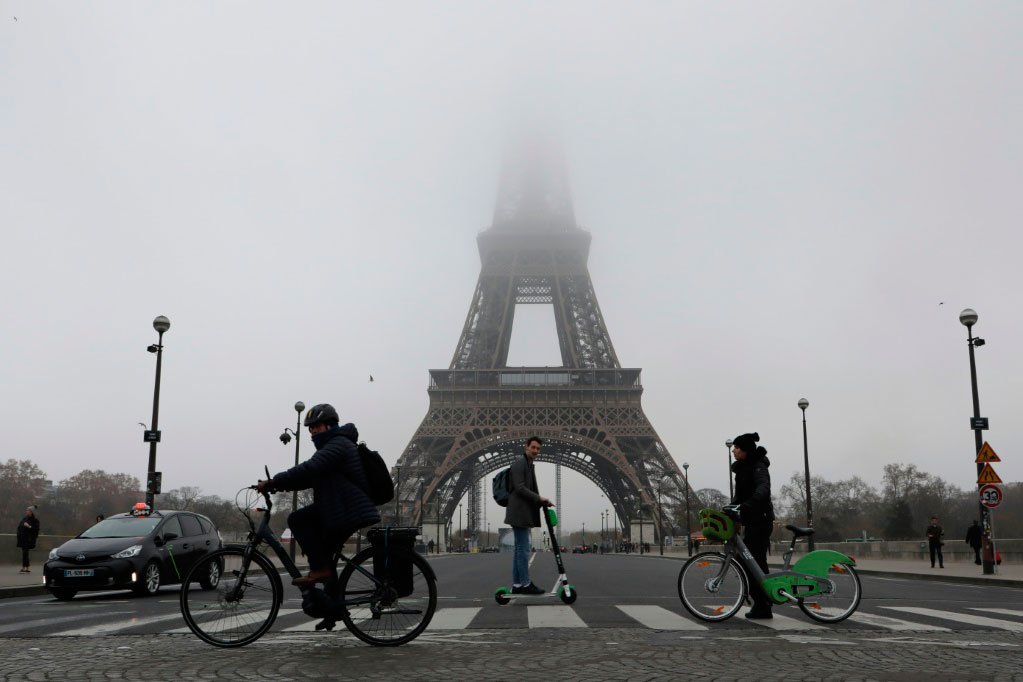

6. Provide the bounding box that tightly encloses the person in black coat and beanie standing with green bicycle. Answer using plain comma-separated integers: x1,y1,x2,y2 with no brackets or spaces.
731,433,774,619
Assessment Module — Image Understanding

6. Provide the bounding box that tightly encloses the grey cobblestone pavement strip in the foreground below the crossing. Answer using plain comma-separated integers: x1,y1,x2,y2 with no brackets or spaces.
6,629,1023,682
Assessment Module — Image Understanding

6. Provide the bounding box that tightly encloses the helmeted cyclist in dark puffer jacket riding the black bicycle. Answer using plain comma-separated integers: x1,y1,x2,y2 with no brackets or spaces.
258,403,381,587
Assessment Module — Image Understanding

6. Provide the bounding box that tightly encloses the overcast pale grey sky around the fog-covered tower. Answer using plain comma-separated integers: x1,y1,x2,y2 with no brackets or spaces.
0,0,1023,529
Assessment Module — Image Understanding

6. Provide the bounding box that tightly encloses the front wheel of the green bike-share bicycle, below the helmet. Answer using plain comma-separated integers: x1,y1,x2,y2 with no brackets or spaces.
678,552,749,622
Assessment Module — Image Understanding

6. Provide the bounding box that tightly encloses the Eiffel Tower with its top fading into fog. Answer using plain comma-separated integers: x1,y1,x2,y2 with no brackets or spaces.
388,140,699,542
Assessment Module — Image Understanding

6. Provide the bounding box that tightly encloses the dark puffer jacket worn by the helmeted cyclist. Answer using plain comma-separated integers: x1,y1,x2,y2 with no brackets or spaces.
273,424,381,530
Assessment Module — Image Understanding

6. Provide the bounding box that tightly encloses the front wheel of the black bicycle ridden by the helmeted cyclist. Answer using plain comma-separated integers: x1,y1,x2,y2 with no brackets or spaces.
181,547,284,647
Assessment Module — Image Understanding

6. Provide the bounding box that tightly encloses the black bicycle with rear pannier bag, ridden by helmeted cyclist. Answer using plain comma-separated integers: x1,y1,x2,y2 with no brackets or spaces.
181,482,437,647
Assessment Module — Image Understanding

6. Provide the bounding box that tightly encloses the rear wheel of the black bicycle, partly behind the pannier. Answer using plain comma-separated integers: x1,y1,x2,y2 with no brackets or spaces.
340,547,437,646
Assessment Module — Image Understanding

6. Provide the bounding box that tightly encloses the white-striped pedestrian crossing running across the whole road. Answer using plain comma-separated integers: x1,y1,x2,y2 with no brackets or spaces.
12,603,1023,637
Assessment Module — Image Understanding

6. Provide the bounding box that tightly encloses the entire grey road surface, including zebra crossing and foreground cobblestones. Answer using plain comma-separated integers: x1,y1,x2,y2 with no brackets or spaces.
6,553,1023,682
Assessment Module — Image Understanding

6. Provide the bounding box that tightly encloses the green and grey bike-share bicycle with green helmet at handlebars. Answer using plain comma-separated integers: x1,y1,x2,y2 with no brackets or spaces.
678,505,862,623
